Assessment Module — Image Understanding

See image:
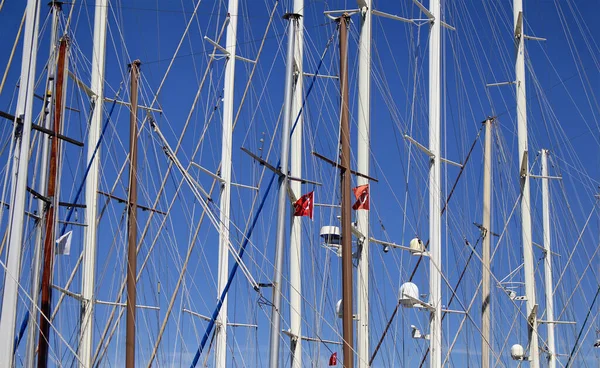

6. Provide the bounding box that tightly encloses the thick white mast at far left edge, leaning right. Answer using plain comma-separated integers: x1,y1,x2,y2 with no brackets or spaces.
0,0,40,367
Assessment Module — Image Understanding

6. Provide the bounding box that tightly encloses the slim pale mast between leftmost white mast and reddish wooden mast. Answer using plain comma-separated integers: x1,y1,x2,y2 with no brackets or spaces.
25,3,61,366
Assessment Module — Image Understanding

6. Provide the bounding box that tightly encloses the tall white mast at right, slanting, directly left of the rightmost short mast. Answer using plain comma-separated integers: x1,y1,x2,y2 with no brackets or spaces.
513,0,540,368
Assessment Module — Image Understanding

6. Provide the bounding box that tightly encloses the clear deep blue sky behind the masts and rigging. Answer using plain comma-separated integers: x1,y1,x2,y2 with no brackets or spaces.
0,0,600,367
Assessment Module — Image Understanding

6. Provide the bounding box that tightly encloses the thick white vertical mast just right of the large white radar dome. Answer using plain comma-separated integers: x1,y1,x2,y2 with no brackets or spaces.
429,0,442,368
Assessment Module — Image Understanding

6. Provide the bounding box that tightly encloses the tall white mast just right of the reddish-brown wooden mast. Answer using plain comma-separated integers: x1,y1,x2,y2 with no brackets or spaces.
79,0,108,367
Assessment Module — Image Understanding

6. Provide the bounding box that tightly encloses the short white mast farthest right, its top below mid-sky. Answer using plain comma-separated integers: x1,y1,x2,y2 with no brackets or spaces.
542,149,556,368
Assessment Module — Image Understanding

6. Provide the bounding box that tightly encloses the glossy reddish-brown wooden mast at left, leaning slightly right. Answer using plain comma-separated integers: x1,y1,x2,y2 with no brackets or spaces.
37,37,69,368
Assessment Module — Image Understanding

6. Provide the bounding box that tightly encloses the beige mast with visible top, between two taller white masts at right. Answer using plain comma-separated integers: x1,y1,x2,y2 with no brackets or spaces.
481,118,492,368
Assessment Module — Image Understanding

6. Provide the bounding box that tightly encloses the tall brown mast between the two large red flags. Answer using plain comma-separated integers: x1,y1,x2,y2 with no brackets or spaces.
338,14,354,368
